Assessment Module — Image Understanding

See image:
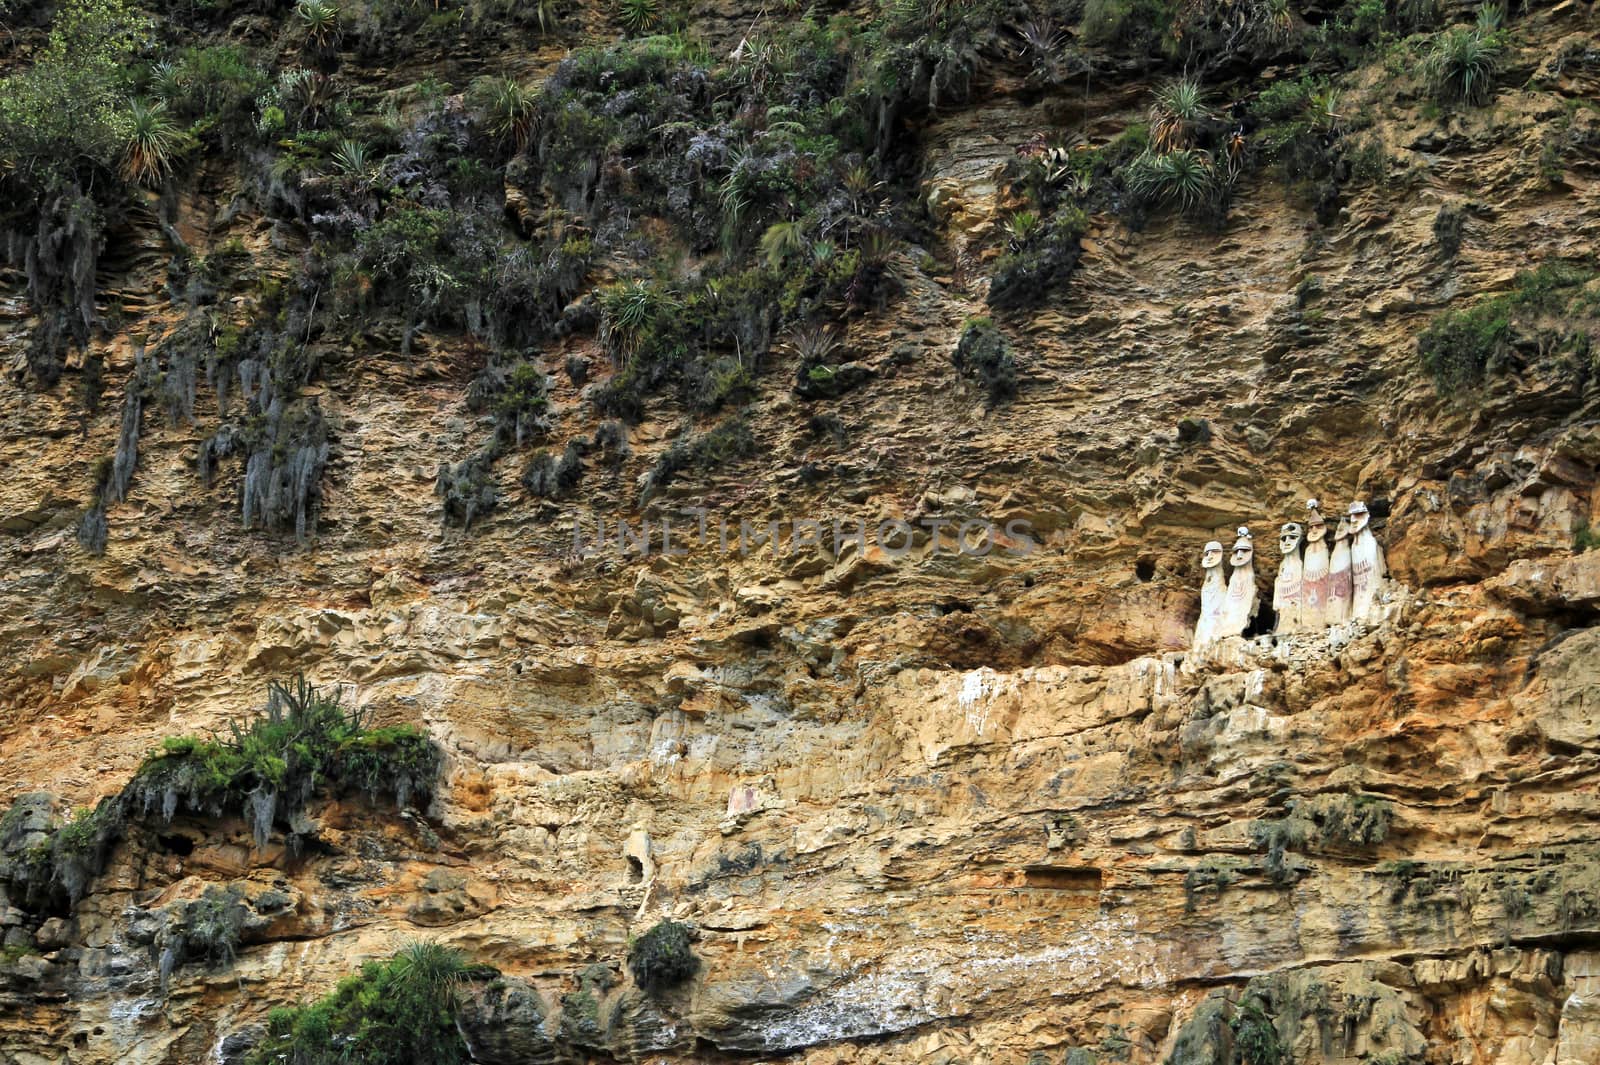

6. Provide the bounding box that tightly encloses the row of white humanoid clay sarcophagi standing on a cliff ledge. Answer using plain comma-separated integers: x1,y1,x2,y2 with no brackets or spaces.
1194,499,1384,649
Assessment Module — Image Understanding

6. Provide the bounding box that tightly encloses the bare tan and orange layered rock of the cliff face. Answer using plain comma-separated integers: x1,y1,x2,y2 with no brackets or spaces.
0,0,1600,1065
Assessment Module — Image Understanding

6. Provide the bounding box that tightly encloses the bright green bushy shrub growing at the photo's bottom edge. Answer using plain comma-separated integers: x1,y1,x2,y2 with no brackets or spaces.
245,942,470,1065
